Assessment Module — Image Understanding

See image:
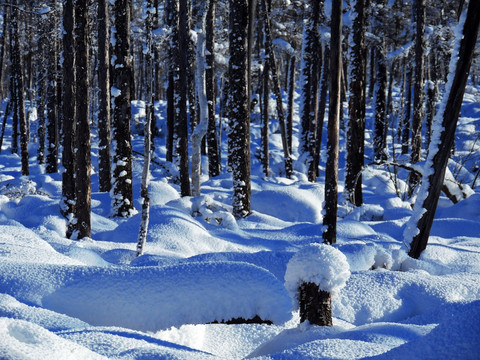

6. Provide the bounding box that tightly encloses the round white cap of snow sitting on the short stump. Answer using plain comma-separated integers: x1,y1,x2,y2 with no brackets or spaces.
285,243,350,299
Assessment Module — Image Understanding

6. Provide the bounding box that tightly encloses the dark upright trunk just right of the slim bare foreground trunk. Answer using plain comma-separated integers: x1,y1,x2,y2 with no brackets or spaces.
345,0,366,206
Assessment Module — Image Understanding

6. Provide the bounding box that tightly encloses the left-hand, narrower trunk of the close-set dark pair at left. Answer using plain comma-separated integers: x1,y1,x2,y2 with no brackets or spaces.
61,0,76,238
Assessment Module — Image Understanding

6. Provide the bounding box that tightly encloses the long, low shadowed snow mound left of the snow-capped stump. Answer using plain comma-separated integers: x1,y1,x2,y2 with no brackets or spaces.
42,262,291,331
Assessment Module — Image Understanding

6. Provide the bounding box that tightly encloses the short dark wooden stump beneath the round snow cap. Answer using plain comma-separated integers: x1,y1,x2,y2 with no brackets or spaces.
298,283,333,326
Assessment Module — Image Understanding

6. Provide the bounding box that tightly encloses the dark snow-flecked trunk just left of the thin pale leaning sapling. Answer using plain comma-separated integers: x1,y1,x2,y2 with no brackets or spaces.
111,0,134,217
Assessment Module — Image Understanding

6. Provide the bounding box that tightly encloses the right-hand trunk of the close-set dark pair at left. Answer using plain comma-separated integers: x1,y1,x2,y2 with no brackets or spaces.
74,0,92,239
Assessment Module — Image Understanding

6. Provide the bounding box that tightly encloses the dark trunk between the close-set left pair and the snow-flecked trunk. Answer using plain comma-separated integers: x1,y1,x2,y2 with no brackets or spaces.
97,0,112,192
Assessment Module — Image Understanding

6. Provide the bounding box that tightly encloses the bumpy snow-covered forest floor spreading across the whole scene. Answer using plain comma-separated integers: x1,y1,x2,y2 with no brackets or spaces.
0,88,480,359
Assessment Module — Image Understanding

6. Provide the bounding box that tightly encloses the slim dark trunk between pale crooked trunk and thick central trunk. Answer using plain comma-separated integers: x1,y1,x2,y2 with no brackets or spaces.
205,0,221,178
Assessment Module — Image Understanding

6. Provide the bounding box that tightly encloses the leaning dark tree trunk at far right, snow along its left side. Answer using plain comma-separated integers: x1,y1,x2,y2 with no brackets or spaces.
404,1,480,258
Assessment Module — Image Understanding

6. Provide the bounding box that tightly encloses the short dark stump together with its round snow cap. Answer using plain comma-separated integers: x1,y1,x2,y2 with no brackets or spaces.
285,243,350,326
